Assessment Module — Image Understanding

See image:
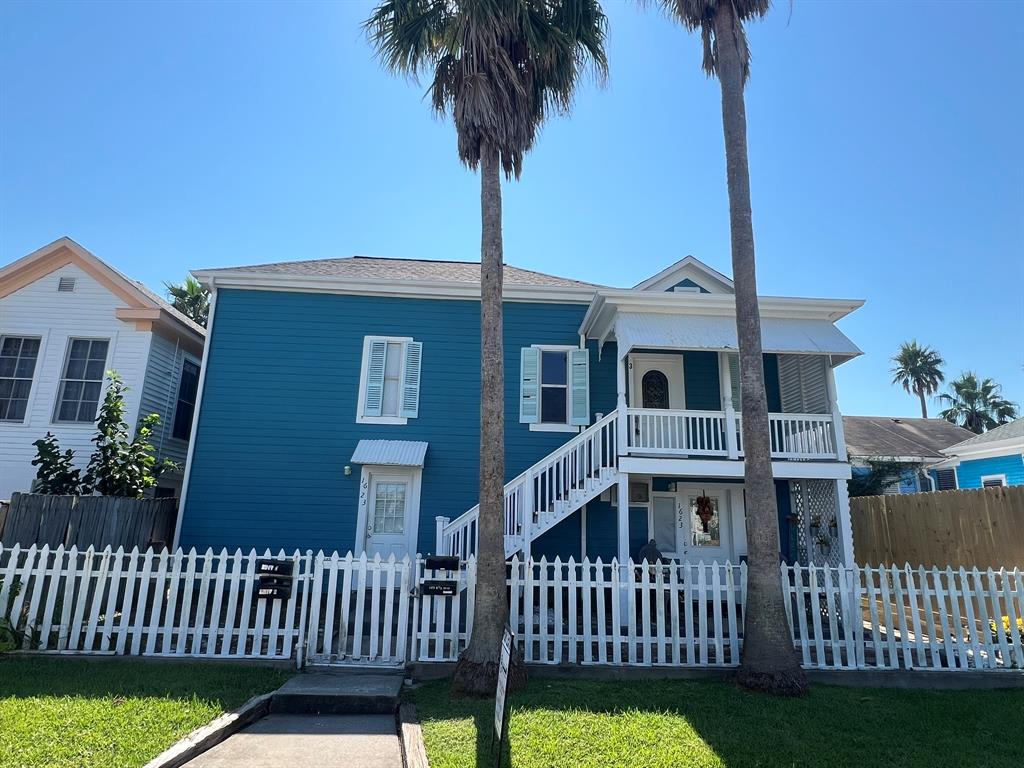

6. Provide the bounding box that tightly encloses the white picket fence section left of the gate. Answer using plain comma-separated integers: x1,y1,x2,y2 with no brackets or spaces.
0,546,305,658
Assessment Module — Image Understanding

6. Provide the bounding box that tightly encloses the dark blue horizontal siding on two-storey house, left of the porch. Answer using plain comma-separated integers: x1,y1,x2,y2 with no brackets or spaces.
181,290,616,552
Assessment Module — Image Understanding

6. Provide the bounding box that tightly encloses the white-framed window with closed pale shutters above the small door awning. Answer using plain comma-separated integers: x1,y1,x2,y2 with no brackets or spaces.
356,336,423,424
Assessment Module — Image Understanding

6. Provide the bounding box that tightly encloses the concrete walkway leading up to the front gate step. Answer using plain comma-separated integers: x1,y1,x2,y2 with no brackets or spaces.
185,715,401,768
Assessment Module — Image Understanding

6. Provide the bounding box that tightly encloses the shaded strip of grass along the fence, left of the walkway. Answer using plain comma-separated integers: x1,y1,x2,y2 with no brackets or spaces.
0,655,292,711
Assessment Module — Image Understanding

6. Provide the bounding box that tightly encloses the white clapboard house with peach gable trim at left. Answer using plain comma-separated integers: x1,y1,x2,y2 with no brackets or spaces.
0,238,206,499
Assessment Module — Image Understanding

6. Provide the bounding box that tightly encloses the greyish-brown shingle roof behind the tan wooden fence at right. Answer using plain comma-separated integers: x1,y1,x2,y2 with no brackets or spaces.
843,416,971,459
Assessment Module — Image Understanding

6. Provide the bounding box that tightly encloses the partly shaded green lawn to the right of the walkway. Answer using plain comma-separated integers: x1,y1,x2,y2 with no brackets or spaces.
413,679,1024,768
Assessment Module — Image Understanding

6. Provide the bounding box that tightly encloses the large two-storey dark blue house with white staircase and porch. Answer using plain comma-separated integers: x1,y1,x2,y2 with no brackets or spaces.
178,256,863,563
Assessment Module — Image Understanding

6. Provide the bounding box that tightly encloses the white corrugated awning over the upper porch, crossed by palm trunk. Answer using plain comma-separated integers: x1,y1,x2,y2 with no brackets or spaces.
614,312,861,362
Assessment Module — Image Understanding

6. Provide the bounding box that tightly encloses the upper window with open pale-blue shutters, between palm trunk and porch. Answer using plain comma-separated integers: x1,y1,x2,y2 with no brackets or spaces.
519,346,590,431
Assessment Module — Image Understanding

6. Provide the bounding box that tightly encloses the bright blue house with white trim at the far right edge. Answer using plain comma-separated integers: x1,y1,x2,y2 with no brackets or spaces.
929,419,1024,490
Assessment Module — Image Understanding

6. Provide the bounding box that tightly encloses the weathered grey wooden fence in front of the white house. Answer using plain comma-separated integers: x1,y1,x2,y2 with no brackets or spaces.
0,494,178,550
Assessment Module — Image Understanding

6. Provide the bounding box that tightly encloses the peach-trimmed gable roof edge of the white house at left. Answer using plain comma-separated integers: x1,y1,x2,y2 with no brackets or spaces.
0,237,206,346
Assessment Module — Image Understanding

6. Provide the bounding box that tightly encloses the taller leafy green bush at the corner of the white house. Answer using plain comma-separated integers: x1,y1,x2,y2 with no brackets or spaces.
82,371,175,499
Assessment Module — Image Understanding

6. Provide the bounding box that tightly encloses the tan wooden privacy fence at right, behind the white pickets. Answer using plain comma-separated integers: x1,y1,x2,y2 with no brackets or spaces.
850,485,1024,568
